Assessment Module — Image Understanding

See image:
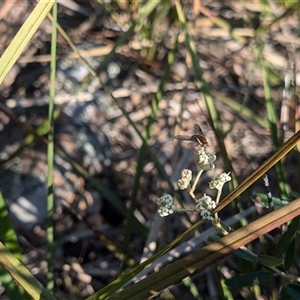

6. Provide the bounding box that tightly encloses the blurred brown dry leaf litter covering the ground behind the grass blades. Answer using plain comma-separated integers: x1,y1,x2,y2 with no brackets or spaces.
0,0,300,299
